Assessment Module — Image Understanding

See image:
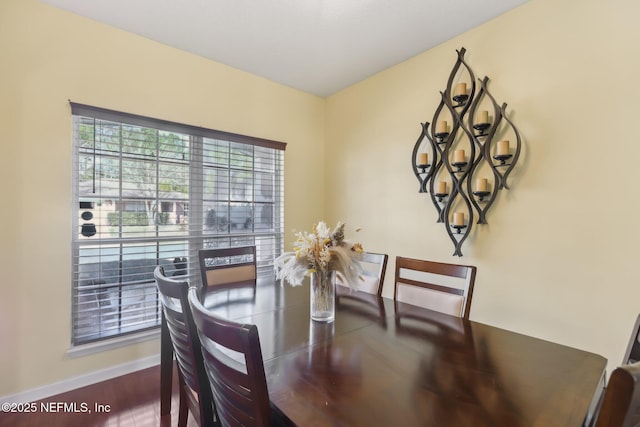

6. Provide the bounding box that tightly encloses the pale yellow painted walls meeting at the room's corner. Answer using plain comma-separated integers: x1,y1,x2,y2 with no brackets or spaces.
0,0,640,396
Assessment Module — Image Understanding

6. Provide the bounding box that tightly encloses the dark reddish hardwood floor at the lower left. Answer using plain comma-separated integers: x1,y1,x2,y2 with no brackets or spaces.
0,366,197,427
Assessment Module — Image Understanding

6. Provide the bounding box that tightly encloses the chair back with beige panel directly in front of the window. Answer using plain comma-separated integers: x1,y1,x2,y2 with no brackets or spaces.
198,246,257,288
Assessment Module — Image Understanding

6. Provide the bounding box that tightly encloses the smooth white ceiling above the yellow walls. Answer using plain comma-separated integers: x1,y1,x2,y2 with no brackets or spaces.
41,0,527,96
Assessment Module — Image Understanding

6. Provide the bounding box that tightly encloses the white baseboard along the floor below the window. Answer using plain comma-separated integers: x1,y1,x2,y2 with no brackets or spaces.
0,354,160,403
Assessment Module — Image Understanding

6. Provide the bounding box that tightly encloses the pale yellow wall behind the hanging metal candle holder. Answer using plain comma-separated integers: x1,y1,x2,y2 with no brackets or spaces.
325,0,640,374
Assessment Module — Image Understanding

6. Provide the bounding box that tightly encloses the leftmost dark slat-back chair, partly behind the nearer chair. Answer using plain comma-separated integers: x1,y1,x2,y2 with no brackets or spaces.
153,266,220,426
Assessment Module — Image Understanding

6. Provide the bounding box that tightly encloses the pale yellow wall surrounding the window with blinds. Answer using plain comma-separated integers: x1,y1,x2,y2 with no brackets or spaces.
0,0,325,396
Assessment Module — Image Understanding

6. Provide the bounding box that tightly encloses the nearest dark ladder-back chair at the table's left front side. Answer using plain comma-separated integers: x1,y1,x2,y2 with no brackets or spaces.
189,288,274,426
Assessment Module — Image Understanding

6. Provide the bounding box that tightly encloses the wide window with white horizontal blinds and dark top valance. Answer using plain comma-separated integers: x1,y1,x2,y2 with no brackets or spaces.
71,103,285,345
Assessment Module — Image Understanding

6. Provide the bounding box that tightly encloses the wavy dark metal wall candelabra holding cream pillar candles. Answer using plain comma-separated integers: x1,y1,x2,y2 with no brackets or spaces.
411,48,522,256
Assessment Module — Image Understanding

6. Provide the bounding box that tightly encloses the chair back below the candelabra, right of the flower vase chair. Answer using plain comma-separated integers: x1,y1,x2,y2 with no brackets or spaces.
393,256,476,319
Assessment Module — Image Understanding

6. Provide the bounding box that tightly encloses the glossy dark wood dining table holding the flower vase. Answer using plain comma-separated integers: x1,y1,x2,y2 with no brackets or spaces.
162,274,606,427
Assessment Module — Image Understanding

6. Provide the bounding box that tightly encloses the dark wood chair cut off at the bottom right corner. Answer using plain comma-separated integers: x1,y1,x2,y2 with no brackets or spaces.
595,362,640,427
